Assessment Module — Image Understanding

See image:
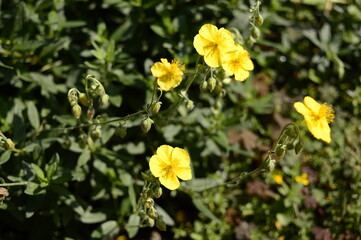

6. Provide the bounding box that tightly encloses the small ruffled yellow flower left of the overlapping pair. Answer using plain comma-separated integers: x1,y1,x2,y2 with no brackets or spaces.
150,58,184,91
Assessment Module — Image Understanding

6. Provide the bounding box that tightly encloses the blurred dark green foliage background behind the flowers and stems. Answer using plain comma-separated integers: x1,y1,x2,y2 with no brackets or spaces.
0,0,361,240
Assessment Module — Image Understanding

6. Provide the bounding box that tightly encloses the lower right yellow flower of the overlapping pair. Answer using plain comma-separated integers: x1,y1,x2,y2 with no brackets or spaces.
222,44,254,81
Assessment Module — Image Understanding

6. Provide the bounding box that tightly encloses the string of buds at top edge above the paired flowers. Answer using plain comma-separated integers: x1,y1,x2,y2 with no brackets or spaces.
246,1,263,47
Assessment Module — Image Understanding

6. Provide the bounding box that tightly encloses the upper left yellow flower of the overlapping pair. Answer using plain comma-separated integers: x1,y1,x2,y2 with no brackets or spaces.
193,24,235,67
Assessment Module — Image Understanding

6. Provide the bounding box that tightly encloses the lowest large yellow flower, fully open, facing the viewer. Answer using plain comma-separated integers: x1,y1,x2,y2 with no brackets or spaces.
149,145,192,190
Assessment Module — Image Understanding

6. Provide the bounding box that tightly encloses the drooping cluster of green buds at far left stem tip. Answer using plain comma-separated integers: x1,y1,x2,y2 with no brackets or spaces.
68,75,109,120
